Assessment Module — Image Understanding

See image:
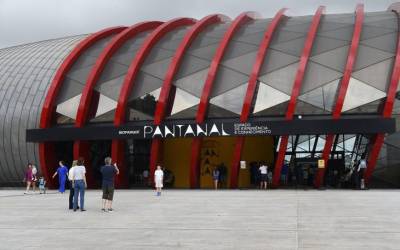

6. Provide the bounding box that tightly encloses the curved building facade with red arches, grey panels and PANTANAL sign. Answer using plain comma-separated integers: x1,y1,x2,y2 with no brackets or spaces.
0,5,400,188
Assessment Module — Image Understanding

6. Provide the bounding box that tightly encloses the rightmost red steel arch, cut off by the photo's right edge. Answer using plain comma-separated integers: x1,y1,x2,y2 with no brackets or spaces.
364,9,400,183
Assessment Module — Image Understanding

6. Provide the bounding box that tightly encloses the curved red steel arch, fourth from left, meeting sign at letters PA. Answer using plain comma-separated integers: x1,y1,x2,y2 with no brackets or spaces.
150,14,228,188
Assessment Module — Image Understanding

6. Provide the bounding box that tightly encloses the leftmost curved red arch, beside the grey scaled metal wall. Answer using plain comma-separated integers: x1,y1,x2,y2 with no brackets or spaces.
39,26,125,187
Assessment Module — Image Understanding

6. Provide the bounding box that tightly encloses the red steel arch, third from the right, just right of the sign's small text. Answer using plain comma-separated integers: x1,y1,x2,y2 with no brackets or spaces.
272,6,325,187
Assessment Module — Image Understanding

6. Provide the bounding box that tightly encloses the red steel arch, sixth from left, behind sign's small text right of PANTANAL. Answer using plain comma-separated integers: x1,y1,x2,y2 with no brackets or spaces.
230,8,286,188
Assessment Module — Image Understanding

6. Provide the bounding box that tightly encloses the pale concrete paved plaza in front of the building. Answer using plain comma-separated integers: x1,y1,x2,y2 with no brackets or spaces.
0,190,400,250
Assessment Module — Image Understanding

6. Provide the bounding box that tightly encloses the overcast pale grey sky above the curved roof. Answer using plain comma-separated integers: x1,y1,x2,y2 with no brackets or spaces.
0,0,399,48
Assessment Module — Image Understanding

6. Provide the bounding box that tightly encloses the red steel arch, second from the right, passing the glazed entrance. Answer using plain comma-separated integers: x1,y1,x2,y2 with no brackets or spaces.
315,4,364,188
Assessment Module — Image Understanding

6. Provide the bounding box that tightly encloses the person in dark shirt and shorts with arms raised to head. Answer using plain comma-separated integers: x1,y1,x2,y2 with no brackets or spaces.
100,157,119,212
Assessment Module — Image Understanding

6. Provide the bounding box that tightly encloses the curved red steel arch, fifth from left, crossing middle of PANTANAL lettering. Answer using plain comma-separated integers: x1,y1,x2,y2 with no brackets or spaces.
186,12,255,188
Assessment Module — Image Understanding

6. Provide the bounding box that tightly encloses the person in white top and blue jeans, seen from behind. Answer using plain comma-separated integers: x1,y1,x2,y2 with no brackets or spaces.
72,157,87,212
